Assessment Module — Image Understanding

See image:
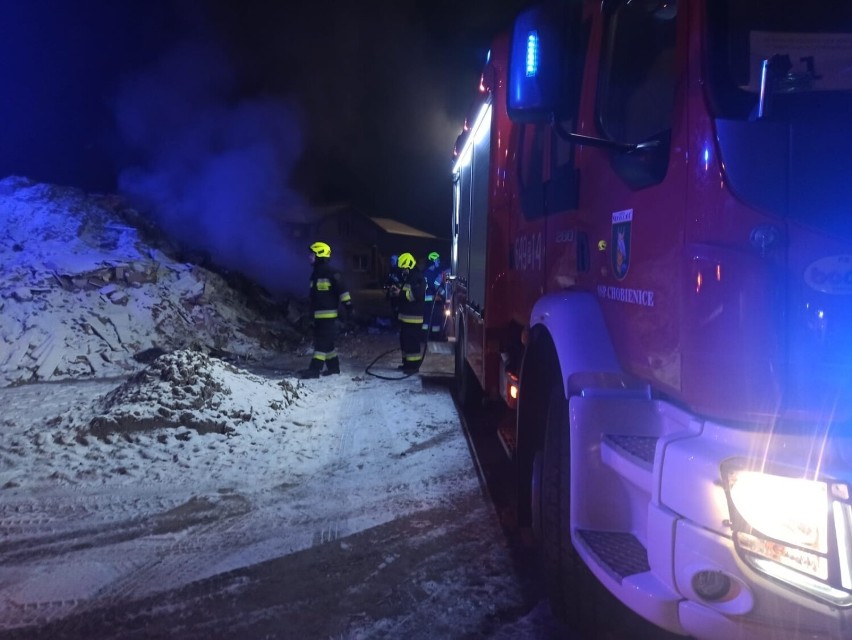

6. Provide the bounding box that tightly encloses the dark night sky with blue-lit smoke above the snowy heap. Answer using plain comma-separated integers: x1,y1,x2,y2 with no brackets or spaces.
0,0,526,237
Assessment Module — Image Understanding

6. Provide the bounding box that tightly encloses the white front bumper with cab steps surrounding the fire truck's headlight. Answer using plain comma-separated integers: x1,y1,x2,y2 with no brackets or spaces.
570,390,852,640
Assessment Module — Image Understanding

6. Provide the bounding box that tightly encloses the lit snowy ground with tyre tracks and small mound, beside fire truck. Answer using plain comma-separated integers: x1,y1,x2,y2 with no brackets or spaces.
0,351,490,626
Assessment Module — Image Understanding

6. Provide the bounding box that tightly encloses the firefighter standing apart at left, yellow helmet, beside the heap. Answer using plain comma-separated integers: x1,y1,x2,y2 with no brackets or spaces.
300,242,352,378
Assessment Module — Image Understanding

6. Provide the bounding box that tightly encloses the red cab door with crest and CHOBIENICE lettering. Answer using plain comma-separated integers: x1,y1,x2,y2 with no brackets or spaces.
578,2,688,391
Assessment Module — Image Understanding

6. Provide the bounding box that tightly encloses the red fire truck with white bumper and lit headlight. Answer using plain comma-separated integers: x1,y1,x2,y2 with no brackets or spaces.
451,0,852,639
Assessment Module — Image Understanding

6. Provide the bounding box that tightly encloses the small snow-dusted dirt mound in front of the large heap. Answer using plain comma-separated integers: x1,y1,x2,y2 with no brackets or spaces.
89,350,307,437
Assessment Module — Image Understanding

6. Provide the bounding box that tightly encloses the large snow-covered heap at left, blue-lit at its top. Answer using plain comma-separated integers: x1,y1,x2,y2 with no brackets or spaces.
0,177,295,387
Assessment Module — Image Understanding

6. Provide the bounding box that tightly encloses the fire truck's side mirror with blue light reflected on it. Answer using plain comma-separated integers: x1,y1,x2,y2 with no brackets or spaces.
506,2,579,123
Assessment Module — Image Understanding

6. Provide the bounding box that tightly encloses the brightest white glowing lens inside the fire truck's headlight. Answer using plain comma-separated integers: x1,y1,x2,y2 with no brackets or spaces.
730,471,828,553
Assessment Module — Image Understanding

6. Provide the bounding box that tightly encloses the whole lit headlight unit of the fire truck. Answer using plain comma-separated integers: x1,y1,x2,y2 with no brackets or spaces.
722,461,852,605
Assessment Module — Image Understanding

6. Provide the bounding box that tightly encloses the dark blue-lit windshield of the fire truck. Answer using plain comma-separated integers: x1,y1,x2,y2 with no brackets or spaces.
705,0,852,230
